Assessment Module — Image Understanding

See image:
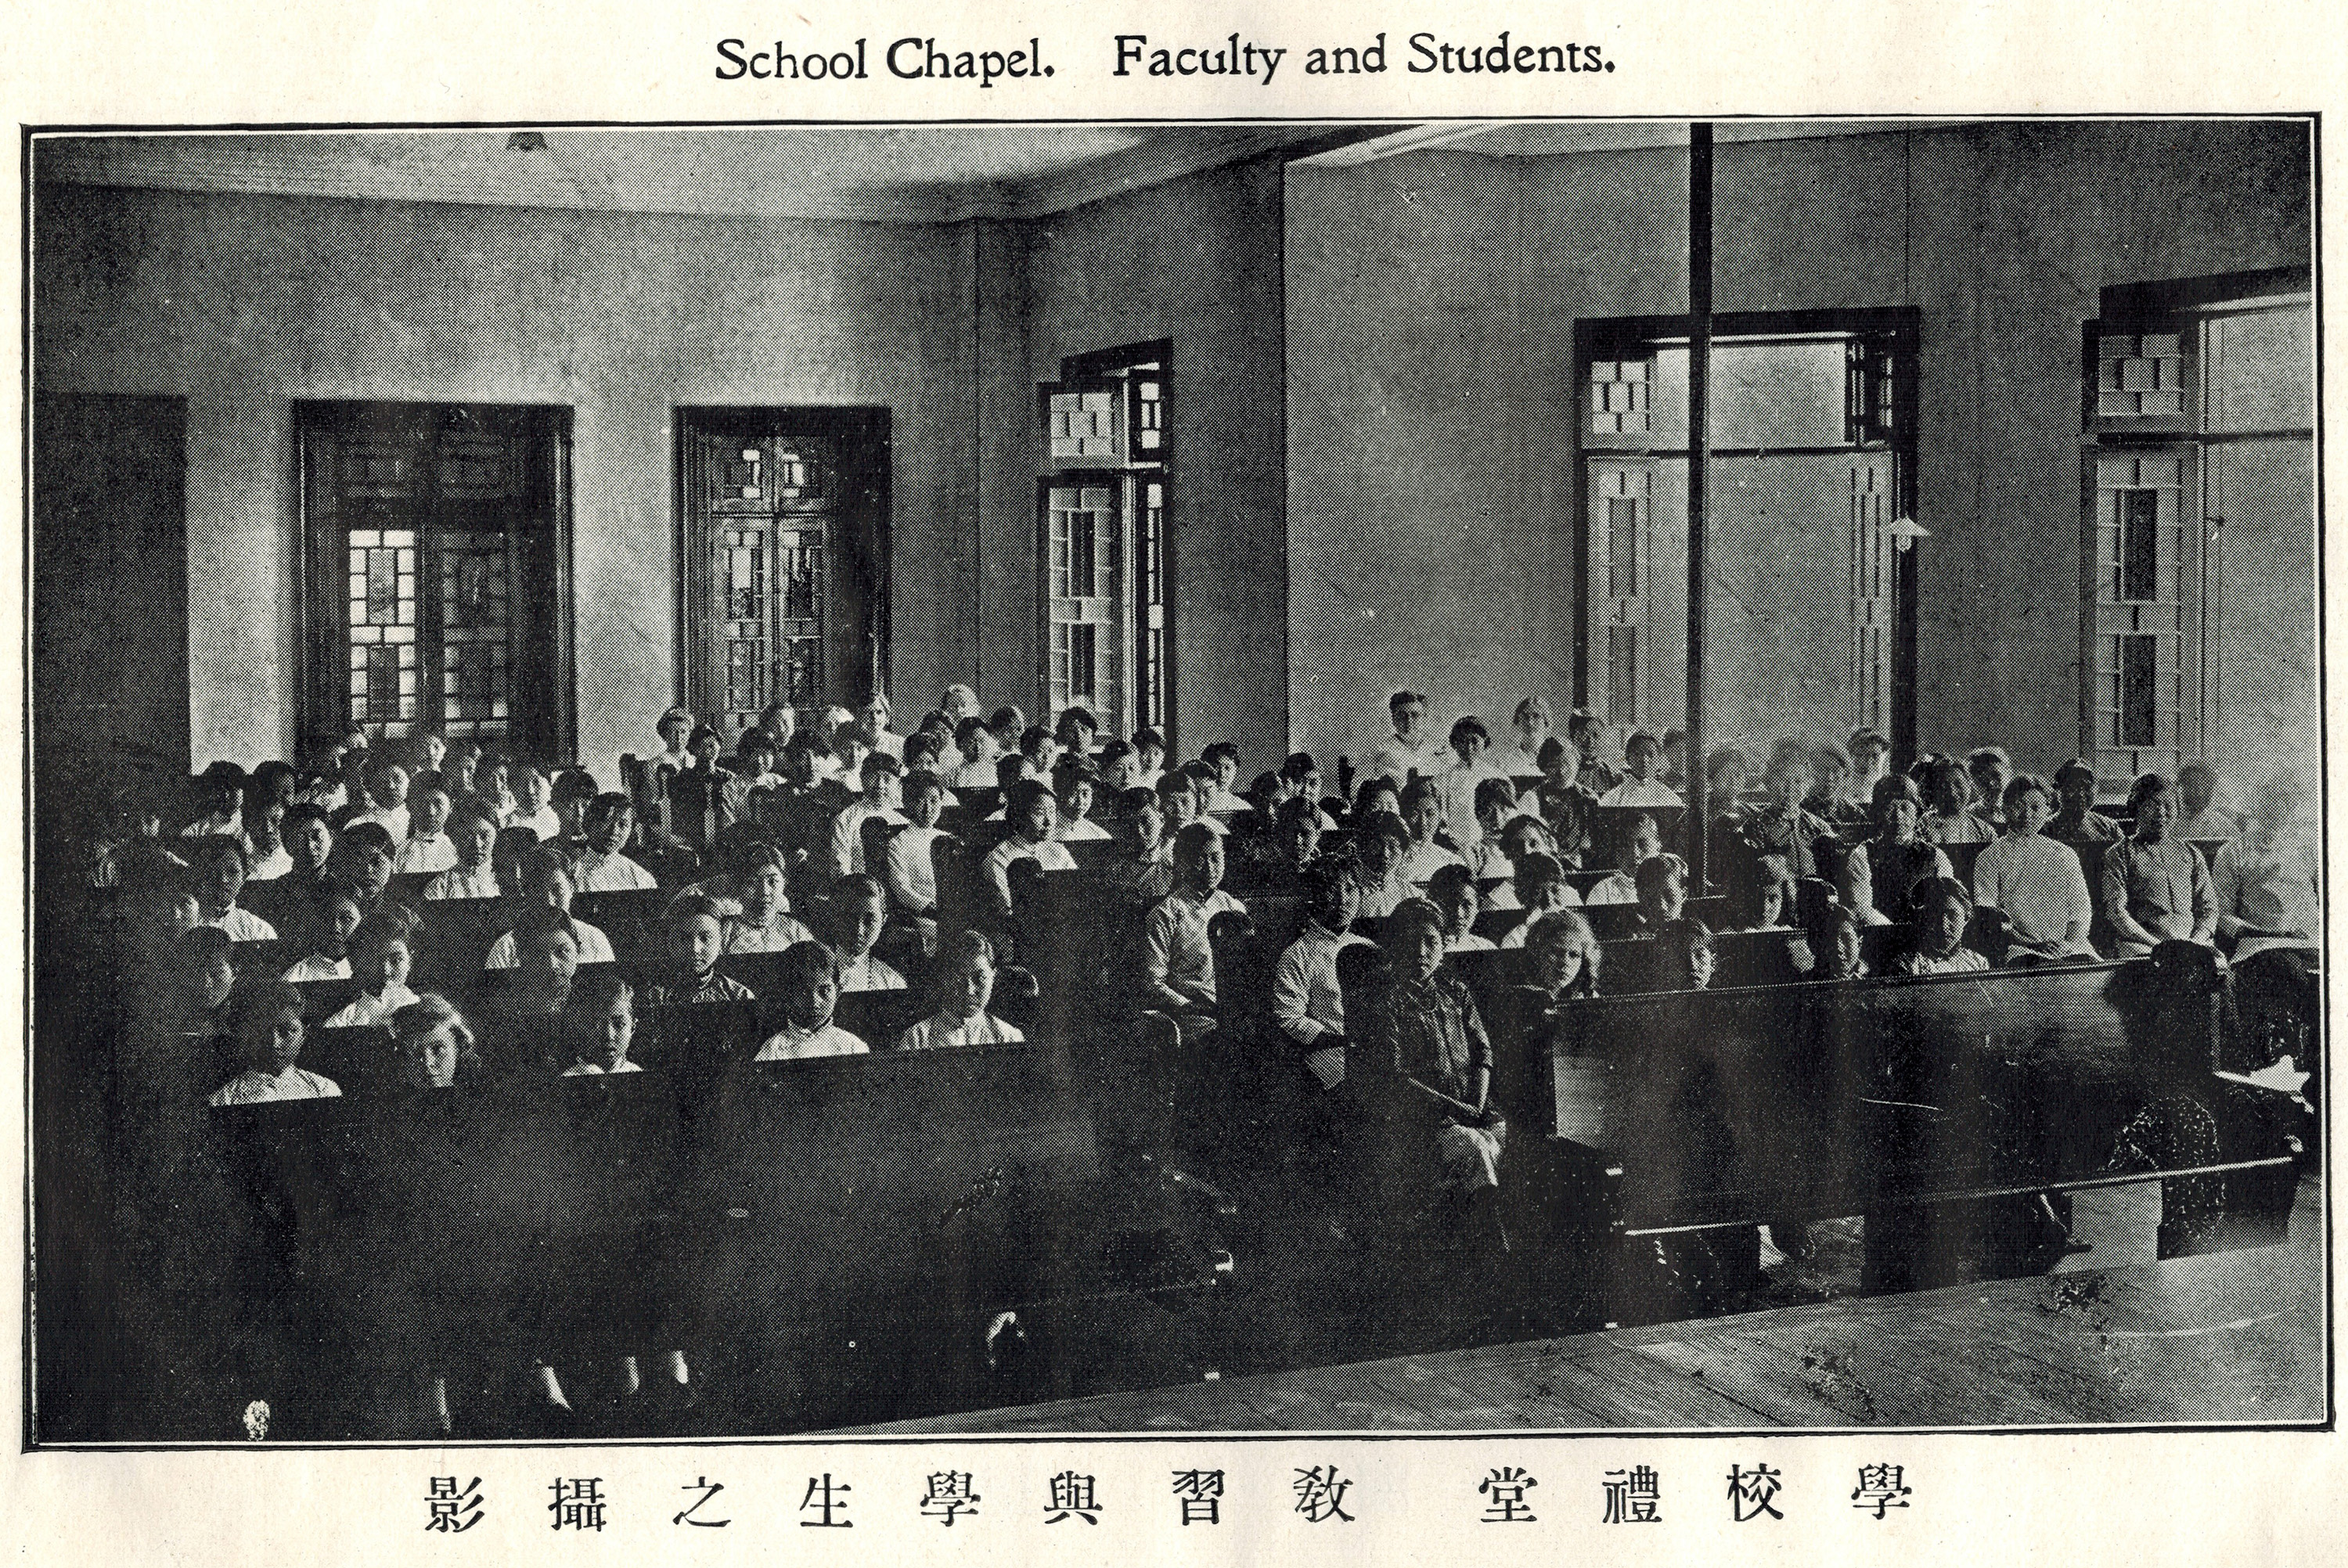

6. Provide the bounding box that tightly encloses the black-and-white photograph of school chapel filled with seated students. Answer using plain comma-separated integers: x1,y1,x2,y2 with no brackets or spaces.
21,113,2332,1455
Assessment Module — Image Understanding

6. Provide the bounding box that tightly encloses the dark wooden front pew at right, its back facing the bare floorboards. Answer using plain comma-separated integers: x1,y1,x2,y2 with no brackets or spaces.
1522,965,2296,1305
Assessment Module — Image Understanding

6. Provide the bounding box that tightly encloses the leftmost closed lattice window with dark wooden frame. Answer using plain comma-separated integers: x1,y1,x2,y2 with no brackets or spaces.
296,404,571,756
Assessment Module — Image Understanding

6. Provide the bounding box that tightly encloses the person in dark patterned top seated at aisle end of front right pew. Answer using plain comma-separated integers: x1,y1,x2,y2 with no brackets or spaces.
1345,899,1507,1197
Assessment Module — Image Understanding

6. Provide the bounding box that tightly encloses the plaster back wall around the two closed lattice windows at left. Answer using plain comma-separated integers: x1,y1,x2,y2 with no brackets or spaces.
33,185,977,770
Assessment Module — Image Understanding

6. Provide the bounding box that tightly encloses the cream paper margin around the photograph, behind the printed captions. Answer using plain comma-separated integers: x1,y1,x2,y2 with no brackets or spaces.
0,0,2348,1568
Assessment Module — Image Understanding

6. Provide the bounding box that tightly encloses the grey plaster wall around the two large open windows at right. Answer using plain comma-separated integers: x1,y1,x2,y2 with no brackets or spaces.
1287,122,2313,765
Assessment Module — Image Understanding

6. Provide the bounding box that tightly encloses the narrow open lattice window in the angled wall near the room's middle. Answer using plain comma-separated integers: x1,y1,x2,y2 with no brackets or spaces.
1035,343,1174,732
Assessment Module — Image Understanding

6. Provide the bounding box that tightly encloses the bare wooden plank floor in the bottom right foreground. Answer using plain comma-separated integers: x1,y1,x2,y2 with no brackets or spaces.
866,1178,2325,1432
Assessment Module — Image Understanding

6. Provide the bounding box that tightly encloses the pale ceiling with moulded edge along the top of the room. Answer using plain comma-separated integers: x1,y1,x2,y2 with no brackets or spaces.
33,120,1963,223
